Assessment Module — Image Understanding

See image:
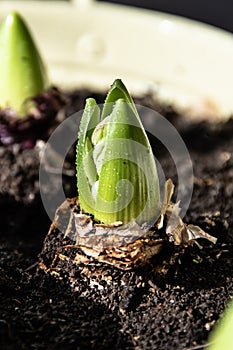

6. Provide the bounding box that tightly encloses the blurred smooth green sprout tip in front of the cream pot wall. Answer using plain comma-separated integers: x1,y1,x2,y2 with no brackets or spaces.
0,12,48,117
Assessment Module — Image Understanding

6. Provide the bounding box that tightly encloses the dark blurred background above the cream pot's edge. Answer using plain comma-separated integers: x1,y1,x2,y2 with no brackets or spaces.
98,0,233,33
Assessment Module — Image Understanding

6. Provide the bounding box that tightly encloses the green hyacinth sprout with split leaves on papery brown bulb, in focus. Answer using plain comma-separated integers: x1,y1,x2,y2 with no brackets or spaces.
76,79,160,225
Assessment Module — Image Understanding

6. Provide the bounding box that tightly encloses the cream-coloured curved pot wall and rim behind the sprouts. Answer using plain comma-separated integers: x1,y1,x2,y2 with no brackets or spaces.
0,0,233,119
